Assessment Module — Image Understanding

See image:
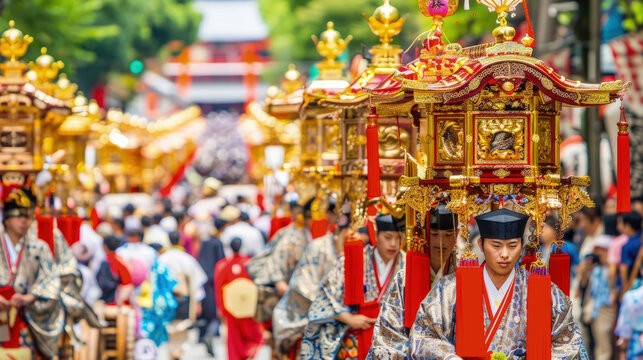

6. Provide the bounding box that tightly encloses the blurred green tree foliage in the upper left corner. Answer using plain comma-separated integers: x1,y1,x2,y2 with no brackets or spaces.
0,0,201,89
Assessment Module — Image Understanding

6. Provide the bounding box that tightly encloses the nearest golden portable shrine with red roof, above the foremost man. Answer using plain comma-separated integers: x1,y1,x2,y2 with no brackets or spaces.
366,0,631,347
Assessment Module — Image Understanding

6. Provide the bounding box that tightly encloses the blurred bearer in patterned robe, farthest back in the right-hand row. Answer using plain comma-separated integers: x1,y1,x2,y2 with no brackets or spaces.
246,198,315,322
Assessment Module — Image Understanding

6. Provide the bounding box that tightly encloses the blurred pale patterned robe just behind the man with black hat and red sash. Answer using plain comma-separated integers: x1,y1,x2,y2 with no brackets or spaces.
272,234,340,354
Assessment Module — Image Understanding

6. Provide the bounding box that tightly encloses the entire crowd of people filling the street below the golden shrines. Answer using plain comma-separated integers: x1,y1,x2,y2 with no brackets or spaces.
0,172,643,360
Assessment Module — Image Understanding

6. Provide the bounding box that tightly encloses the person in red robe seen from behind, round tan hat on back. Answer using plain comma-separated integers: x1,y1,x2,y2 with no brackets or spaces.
214,237,263,360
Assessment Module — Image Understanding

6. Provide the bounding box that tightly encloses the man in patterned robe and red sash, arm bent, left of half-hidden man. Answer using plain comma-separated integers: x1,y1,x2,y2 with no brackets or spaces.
301,215,404,360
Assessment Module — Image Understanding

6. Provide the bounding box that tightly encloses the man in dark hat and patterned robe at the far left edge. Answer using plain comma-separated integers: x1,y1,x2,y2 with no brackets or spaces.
0,188,65,358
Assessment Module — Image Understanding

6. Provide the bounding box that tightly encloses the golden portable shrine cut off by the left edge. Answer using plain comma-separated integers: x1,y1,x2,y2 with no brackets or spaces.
0,21,100,211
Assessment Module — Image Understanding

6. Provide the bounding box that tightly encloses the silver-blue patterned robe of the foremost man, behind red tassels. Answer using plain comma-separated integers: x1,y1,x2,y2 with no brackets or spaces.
410,269,589,360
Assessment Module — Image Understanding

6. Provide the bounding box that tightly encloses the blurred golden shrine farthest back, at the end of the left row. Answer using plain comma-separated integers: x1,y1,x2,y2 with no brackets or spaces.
89,106,205,193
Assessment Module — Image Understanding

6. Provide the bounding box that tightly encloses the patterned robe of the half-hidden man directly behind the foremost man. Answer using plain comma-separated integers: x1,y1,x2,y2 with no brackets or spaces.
366,256,456,360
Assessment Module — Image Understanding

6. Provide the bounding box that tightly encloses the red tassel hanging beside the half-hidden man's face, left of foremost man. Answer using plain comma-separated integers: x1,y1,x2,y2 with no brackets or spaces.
404,250,431,329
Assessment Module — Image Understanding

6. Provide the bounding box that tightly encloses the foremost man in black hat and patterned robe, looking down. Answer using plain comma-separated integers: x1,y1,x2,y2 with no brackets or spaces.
410,209,588,360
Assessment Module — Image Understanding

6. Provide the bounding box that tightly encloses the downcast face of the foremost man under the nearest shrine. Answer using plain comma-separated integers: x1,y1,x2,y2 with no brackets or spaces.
478,238,522,276
